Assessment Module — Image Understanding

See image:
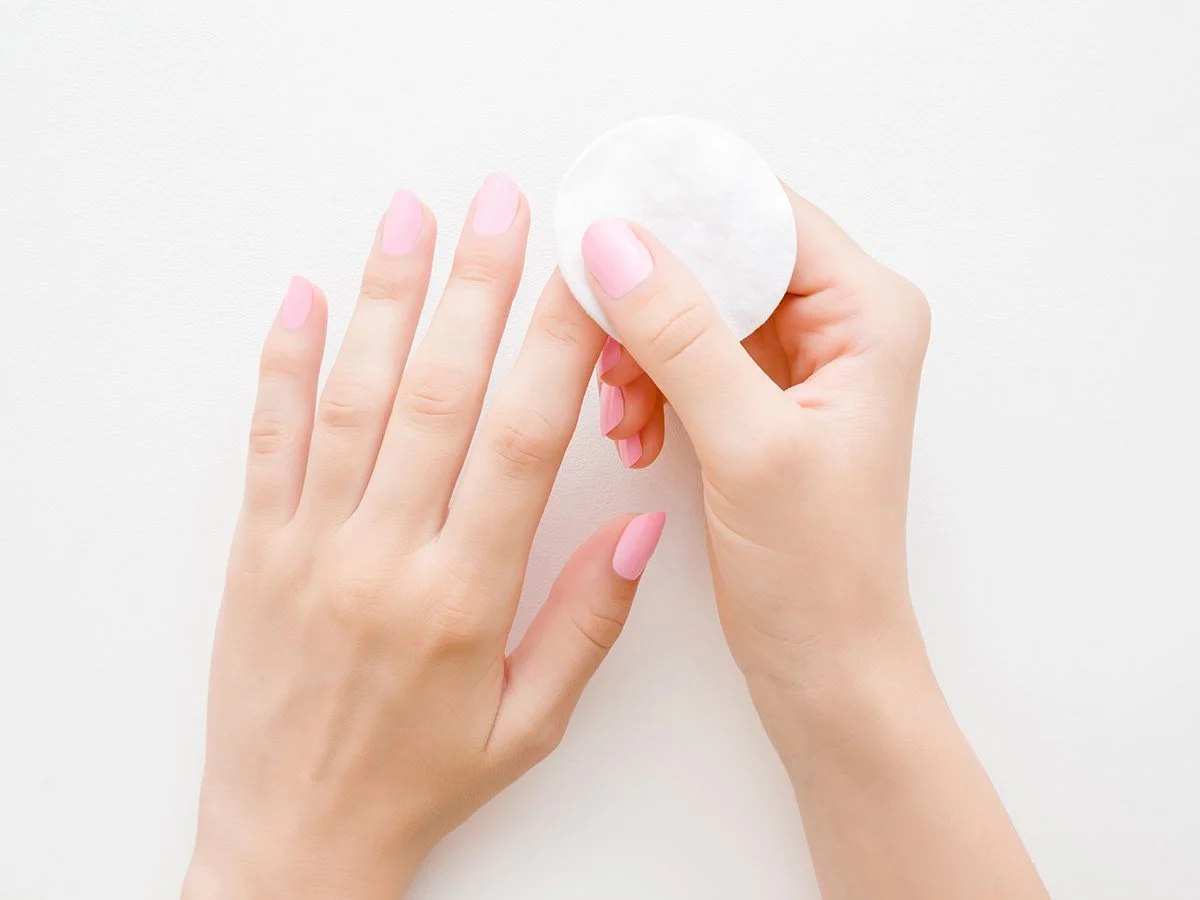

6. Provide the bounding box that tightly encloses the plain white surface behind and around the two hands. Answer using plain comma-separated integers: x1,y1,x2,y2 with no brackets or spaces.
0,0,1200,900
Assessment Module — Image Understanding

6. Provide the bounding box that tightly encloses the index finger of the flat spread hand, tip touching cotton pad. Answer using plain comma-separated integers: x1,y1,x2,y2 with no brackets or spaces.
440,271,604,588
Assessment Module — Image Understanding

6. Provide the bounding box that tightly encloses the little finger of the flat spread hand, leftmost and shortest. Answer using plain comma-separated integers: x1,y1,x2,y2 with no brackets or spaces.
242,275,326,527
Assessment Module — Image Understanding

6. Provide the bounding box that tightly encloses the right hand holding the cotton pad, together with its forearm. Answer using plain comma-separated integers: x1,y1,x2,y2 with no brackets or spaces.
583,194,1046,900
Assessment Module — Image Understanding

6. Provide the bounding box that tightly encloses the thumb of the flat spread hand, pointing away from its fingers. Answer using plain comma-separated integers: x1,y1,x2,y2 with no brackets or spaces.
490,512,666,764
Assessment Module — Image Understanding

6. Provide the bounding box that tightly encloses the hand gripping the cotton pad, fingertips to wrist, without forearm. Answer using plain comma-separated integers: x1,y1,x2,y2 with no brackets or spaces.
583,192,929,689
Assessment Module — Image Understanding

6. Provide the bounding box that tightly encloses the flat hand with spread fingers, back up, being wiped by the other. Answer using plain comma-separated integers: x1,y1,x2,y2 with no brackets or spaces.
184,175,662,900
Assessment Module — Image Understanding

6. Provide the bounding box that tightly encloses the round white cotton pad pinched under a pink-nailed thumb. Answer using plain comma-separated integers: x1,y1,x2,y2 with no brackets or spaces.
554,115,796,340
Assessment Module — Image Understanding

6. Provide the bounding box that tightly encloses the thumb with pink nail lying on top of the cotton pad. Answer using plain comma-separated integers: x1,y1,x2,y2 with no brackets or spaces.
582,218,778,442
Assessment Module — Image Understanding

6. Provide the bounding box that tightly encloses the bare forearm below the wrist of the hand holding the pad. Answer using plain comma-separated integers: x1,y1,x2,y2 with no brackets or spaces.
751,633,1046,900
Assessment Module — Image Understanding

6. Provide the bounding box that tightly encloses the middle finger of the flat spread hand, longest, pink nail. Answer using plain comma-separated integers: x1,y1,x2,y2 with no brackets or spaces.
365,174,529,536
